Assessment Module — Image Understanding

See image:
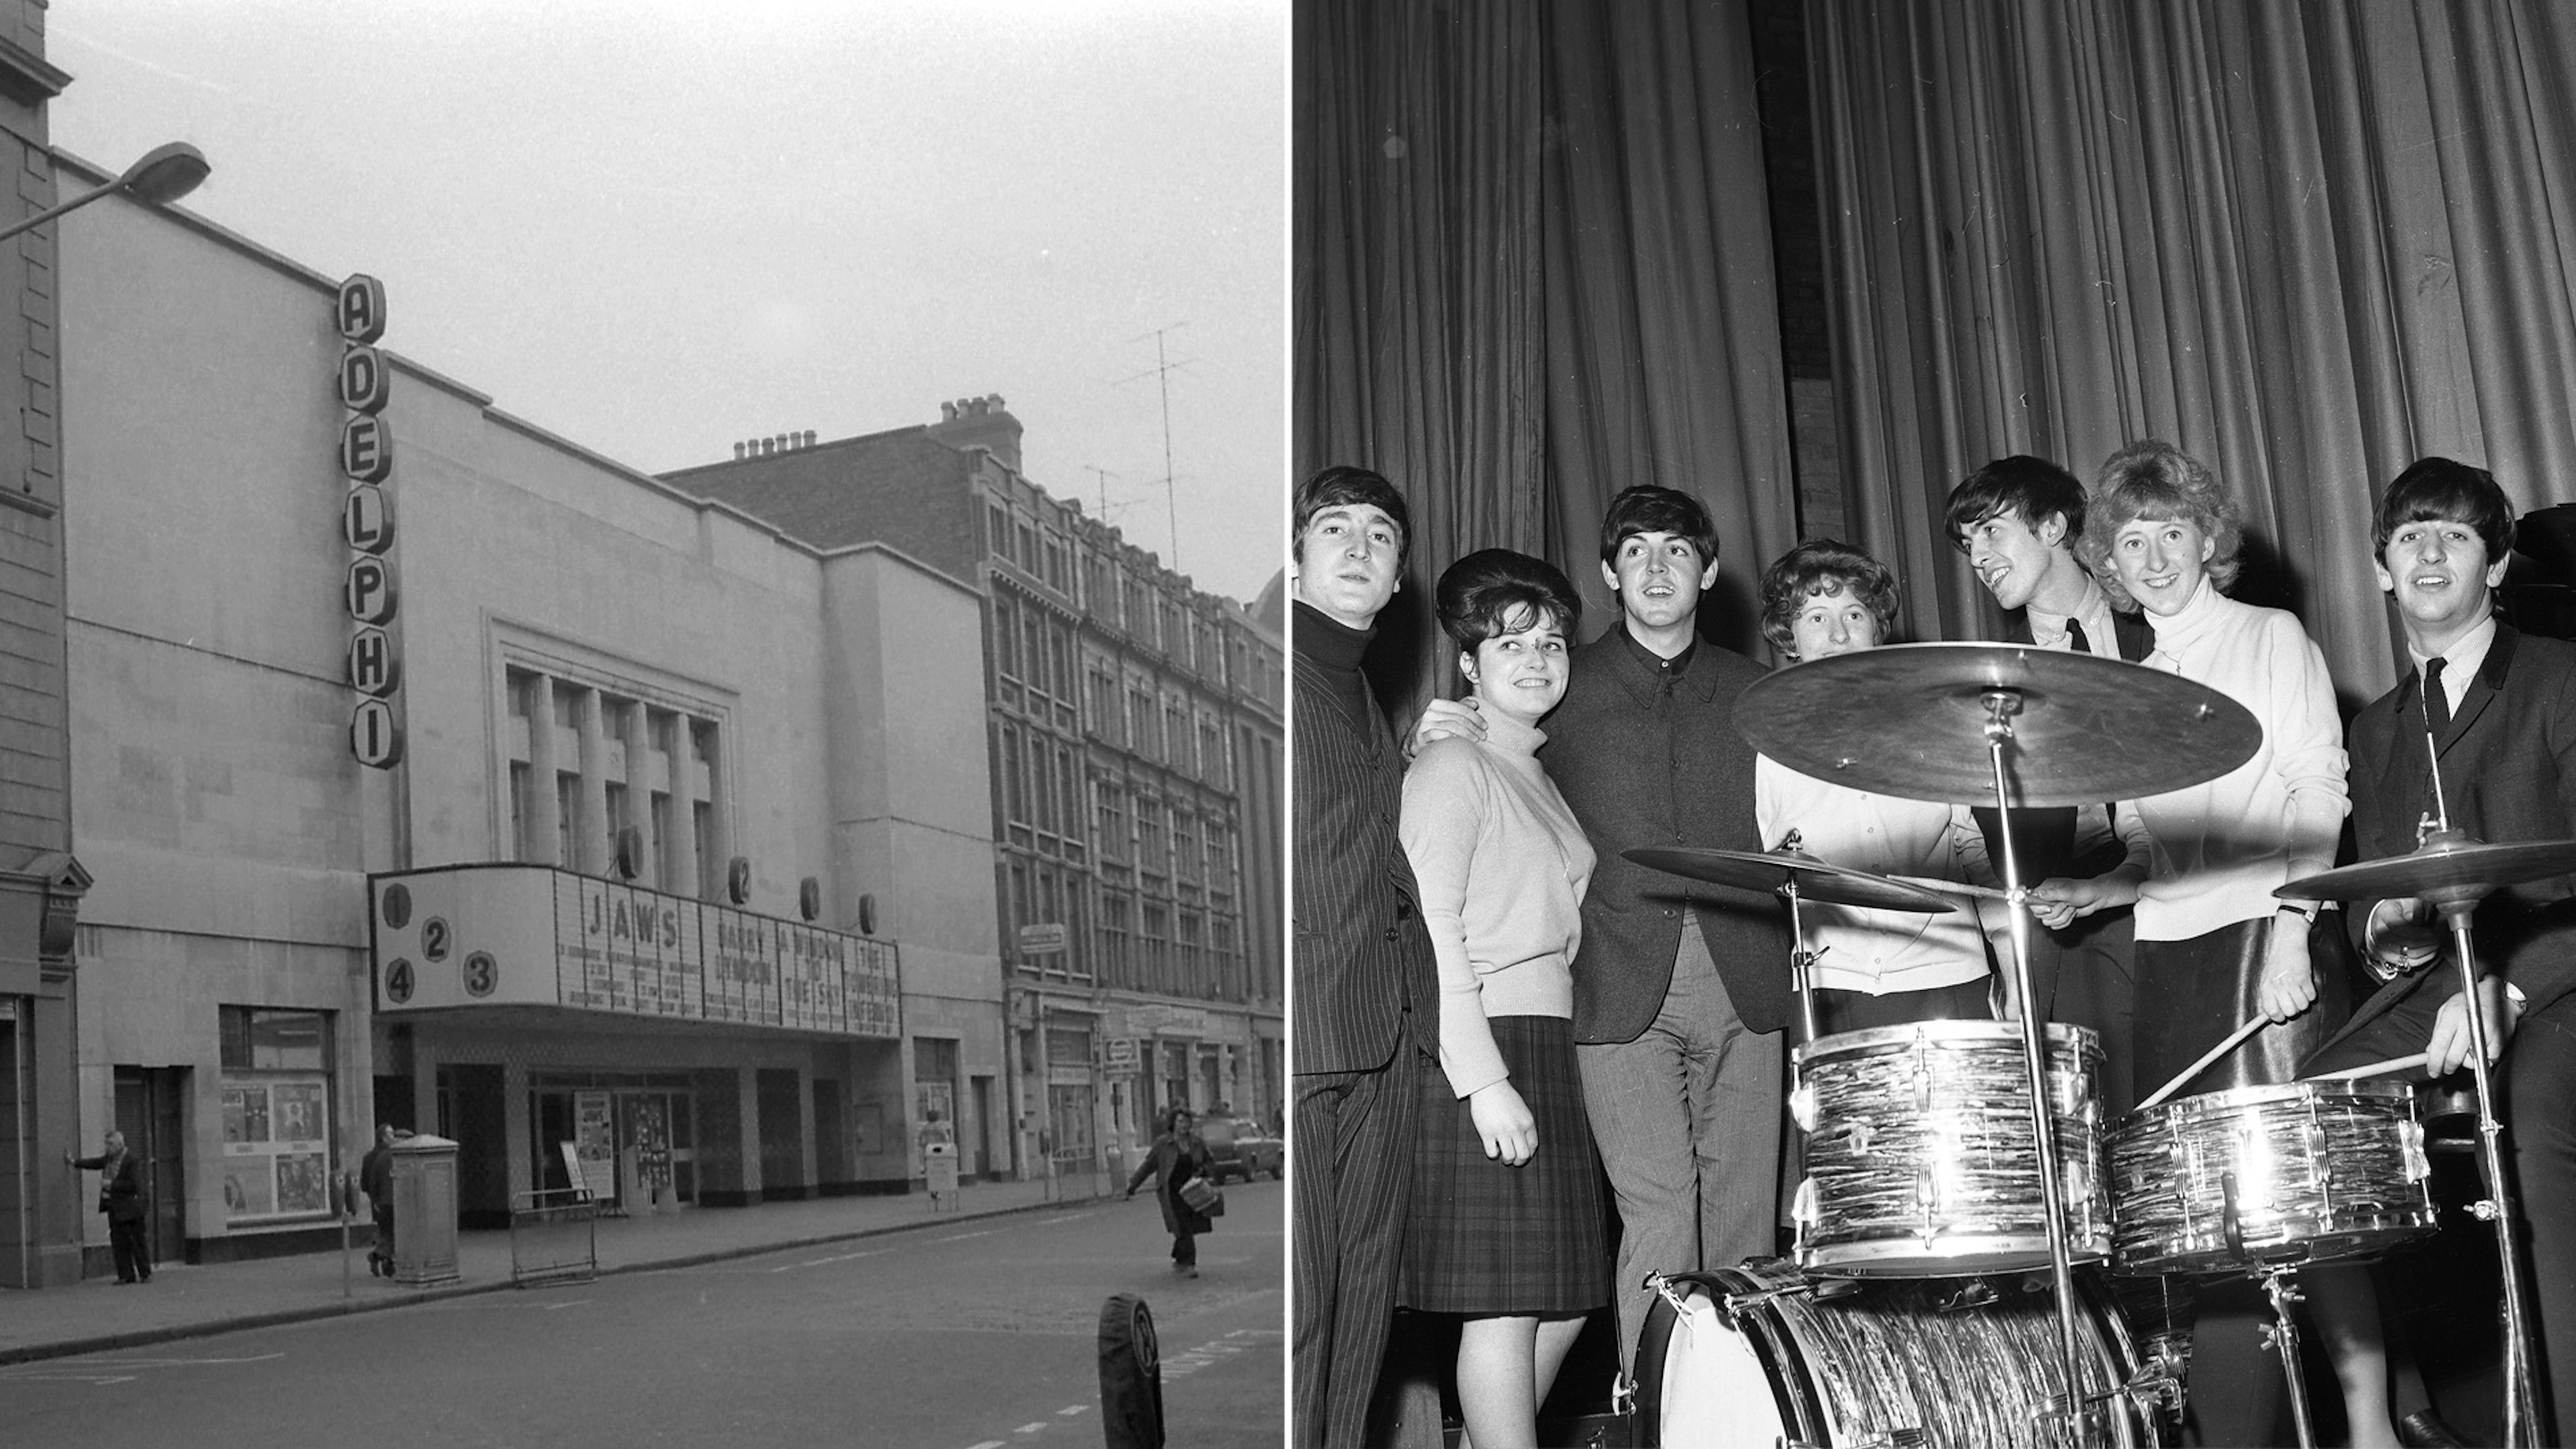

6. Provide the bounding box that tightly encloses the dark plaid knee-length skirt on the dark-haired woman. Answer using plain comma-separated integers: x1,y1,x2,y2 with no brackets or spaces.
1401,1016,1610,1315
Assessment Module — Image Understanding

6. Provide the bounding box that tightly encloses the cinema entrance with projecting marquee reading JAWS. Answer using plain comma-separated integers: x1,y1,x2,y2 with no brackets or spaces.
368,864,920,1212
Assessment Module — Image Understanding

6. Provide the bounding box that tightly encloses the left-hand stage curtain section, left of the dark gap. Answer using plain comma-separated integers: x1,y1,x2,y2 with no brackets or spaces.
1293,0,1795,714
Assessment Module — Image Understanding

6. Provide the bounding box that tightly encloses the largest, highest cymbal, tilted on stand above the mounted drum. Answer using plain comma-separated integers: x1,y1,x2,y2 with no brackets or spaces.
1736,645,2262,804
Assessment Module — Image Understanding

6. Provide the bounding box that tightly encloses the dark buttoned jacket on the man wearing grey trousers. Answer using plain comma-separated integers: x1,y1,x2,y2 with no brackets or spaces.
1538,624,1790,1042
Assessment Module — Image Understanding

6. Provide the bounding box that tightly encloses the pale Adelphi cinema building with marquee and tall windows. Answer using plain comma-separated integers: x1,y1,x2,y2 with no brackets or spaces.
46,165,1012,1260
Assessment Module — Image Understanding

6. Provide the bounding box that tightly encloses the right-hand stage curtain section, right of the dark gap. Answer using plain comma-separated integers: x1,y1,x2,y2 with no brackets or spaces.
1809,0,2576,701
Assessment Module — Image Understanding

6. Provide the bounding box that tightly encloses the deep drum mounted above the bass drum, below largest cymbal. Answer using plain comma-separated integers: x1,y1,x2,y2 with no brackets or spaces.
1790,1021,2110,1279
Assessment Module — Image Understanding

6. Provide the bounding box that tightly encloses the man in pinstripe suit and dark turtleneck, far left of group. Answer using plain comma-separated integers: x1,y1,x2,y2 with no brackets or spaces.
1291,467,1440,1449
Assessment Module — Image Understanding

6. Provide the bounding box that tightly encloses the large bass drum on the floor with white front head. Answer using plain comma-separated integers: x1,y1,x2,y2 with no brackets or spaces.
1635,1258,2156,1449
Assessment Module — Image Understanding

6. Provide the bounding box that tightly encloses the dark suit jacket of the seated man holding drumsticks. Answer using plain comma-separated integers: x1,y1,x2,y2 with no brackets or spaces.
2328,621,2576,1046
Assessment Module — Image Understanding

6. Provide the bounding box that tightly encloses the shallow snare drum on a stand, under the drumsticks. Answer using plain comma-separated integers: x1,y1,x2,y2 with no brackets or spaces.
2110,1080,2434,1274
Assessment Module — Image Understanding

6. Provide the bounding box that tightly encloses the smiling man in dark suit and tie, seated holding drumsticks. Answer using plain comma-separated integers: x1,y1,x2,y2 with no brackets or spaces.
2306,459,2576,1444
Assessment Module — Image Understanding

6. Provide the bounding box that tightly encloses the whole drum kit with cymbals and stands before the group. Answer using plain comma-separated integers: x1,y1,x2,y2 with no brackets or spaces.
1628,645,2544,1449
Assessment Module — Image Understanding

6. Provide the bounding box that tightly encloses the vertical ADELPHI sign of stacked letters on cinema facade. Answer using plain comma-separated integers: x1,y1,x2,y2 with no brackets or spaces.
332,273,402,771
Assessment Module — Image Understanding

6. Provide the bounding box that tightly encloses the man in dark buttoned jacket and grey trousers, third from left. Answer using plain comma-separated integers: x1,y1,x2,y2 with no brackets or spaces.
1504,485,1790,1364
